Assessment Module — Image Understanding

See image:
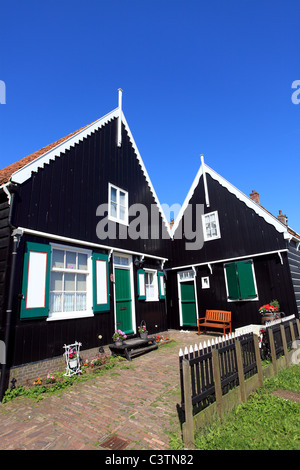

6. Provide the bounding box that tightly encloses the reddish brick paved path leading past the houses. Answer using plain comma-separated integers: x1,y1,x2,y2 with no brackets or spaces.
0,330,213,450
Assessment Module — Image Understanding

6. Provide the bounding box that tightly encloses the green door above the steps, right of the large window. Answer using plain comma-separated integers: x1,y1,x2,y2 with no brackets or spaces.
115,268,133,334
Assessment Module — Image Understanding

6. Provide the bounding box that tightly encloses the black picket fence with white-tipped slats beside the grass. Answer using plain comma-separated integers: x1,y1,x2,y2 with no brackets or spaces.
179,318,300,420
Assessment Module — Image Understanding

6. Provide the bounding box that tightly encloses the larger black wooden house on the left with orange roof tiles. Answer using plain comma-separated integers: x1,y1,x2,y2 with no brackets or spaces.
0,93,170,392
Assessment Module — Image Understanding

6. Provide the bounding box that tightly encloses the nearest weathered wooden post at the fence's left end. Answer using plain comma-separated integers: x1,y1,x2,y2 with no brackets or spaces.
182,358,195,447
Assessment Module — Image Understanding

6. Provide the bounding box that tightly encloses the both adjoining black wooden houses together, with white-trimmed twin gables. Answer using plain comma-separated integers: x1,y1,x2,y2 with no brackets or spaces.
0,90,300,393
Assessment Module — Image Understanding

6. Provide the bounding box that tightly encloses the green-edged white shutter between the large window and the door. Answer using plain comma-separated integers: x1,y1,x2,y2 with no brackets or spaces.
93,253,110,313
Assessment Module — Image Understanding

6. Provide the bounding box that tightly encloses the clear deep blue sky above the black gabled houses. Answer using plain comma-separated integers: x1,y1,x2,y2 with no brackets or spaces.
0,0,300,233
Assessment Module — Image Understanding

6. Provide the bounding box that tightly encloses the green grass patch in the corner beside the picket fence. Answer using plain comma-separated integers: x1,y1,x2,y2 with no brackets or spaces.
192,365,300,450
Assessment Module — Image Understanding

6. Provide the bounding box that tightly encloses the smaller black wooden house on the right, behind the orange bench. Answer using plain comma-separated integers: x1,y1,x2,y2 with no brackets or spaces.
167,158,300,329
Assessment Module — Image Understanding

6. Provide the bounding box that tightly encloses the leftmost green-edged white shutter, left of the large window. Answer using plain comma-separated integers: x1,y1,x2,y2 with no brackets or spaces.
20,242,51,320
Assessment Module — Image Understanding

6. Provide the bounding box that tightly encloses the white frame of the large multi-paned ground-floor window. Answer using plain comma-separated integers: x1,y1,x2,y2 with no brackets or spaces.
47,243,94,321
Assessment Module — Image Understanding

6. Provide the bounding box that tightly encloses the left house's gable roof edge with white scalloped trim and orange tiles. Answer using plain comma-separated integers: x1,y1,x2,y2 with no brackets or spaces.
0,107,171,236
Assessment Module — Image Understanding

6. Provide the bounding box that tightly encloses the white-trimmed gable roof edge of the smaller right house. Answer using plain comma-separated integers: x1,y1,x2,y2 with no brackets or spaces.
172,162,290,238
